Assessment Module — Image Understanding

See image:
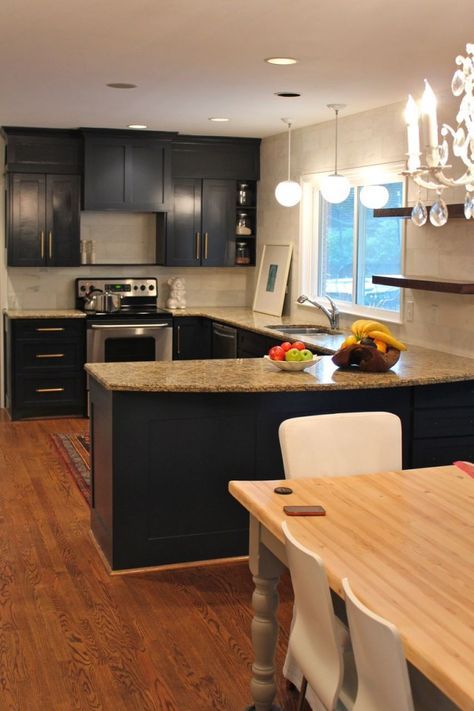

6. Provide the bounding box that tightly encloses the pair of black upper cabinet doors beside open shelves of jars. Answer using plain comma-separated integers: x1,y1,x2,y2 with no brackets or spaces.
165,178,235,267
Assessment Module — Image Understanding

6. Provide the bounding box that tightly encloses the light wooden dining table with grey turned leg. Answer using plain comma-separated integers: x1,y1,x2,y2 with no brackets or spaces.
229,466,474,711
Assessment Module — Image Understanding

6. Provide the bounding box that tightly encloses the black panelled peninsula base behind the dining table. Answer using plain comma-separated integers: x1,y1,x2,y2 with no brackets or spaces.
91,380,411,569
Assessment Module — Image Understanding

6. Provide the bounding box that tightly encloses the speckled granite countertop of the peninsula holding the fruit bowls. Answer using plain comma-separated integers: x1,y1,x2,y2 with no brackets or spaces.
86,346,474,393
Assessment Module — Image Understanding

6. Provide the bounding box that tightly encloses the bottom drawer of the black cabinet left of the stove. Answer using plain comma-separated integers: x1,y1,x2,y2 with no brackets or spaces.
15,374,84,415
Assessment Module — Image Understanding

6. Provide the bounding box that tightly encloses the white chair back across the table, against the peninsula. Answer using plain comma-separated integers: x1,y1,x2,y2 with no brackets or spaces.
278,412,402,479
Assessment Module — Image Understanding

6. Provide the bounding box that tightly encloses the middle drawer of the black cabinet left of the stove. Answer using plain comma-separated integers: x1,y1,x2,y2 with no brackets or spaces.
15,340,84,372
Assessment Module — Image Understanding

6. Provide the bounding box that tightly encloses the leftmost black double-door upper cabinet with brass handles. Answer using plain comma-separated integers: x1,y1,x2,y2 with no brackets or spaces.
7,173,81,267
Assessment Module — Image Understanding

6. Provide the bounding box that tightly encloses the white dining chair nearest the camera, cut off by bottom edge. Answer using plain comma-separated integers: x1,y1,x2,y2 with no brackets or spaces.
342,578,414,711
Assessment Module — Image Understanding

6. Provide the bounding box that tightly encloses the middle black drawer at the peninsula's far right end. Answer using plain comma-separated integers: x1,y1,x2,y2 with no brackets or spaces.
413,407,474,439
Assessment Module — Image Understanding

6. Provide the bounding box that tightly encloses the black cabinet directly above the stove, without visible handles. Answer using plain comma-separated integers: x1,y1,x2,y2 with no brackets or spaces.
83,130,176,212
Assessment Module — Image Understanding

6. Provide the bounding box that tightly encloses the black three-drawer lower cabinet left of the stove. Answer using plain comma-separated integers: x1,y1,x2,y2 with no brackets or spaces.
5,318,86,420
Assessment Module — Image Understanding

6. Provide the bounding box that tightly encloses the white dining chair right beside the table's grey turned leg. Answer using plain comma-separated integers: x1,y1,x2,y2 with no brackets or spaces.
282,521,355,711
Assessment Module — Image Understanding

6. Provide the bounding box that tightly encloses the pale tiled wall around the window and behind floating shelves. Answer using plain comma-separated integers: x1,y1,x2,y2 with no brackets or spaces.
258,94,474,355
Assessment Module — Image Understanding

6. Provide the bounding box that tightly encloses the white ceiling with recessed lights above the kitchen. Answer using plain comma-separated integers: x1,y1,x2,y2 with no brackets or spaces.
0,0,474,137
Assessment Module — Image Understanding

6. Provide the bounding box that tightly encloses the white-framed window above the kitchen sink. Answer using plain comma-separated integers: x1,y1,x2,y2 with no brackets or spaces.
301,168,404,318
